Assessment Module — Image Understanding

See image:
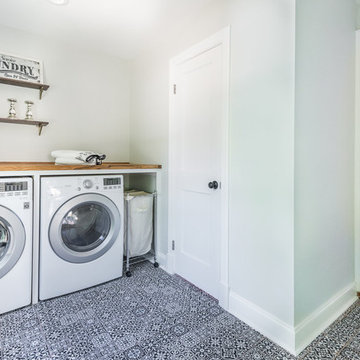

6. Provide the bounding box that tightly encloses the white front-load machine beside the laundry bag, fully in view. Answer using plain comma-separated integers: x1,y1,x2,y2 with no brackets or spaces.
39,175,124,300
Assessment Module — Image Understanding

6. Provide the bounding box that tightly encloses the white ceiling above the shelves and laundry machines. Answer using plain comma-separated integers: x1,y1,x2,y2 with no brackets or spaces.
0,0,213,59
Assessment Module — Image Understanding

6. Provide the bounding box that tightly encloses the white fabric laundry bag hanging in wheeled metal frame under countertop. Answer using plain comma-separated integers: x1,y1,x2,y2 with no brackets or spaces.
124,190,153,257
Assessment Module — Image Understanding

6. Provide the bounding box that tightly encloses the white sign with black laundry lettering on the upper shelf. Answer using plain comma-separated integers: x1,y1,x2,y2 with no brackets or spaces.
0,53,43,84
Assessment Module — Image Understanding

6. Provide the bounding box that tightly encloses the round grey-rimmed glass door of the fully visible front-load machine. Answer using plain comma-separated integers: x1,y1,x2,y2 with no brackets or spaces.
49,194,122,263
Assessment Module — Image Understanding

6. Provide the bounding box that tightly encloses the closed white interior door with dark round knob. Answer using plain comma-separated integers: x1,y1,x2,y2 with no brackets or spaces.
169,29,227,299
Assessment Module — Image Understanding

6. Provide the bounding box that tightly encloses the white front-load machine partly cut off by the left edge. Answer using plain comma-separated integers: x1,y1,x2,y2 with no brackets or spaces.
0,178,33,314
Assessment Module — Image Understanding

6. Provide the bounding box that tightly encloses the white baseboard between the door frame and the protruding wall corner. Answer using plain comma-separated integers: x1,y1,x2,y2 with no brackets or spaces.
229,290,295,355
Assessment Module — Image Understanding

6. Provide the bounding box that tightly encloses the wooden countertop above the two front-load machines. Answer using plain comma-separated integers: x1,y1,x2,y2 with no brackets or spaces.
0,162,161,171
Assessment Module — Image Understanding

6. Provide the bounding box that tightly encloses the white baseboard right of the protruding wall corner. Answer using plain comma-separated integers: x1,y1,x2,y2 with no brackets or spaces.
295,284,357,355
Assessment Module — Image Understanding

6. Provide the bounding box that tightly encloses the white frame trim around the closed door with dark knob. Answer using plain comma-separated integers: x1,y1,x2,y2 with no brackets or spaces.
167,26,230,309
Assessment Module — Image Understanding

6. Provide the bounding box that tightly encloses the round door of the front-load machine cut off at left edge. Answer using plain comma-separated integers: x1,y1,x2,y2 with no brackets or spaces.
0,206,25,279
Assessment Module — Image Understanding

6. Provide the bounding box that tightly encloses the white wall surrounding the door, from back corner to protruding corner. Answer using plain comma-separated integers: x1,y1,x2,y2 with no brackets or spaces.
130,0,295,325
